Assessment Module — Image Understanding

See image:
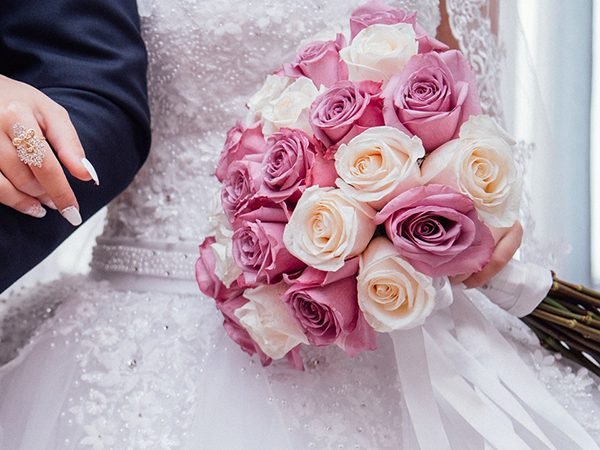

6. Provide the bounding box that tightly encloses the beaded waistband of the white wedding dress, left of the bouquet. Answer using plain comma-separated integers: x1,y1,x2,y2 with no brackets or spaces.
90,238,199,293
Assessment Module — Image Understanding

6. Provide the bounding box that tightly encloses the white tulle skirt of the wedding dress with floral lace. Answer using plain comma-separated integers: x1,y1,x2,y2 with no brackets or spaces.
0,277,600,450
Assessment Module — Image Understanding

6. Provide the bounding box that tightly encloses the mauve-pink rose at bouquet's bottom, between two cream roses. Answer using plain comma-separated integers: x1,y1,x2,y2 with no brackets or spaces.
284,258,376,356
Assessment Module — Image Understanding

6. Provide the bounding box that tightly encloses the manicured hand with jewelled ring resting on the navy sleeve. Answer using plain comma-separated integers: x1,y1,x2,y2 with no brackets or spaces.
0,75,97,225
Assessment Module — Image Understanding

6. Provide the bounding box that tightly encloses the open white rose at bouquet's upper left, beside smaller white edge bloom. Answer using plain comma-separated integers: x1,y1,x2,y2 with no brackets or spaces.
262,77,319,136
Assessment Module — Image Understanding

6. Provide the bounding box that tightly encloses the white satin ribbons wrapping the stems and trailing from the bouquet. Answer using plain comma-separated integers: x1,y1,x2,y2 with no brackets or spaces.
392,263,599,450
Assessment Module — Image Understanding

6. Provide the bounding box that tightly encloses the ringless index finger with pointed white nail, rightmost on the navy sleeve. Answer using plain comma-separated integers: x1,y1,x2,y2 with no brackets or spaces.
38,101,100,185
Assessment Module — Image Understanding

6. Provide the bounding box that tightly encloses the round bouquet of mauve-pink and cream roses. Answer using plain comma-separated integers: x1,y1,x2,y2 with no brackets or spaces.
196,2,591,367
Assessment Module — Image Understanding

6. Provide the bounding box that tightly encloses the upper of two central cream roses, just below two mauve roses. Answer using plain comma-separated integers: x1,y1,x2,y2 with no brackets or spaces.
335,127,425,209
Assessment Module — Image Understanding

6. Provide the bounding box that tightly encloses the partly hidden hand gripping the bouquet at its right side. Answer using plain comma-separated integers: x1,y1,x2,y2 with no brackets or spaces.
450,222,523,288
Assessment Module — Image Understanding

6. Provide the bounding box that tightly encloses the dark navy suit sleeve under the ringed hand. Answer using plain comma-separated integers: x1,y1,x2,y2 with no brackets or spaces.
0,0,150,292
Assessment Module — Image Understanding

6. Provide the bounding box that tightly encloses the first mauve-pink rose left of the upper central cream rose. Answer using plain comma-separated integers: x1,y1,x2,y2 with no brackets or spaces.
261,128,316,203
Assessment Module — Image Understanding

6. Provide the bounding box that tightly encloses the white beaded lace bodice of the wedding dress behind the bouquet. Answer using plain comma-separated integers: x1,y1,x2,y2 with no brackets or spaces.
92,0,502,278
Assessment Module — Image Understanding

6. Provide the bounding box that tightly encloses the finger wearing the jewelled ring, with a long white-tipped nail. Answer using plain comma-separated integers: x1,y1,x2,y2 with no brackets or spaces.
11,108,81,226
